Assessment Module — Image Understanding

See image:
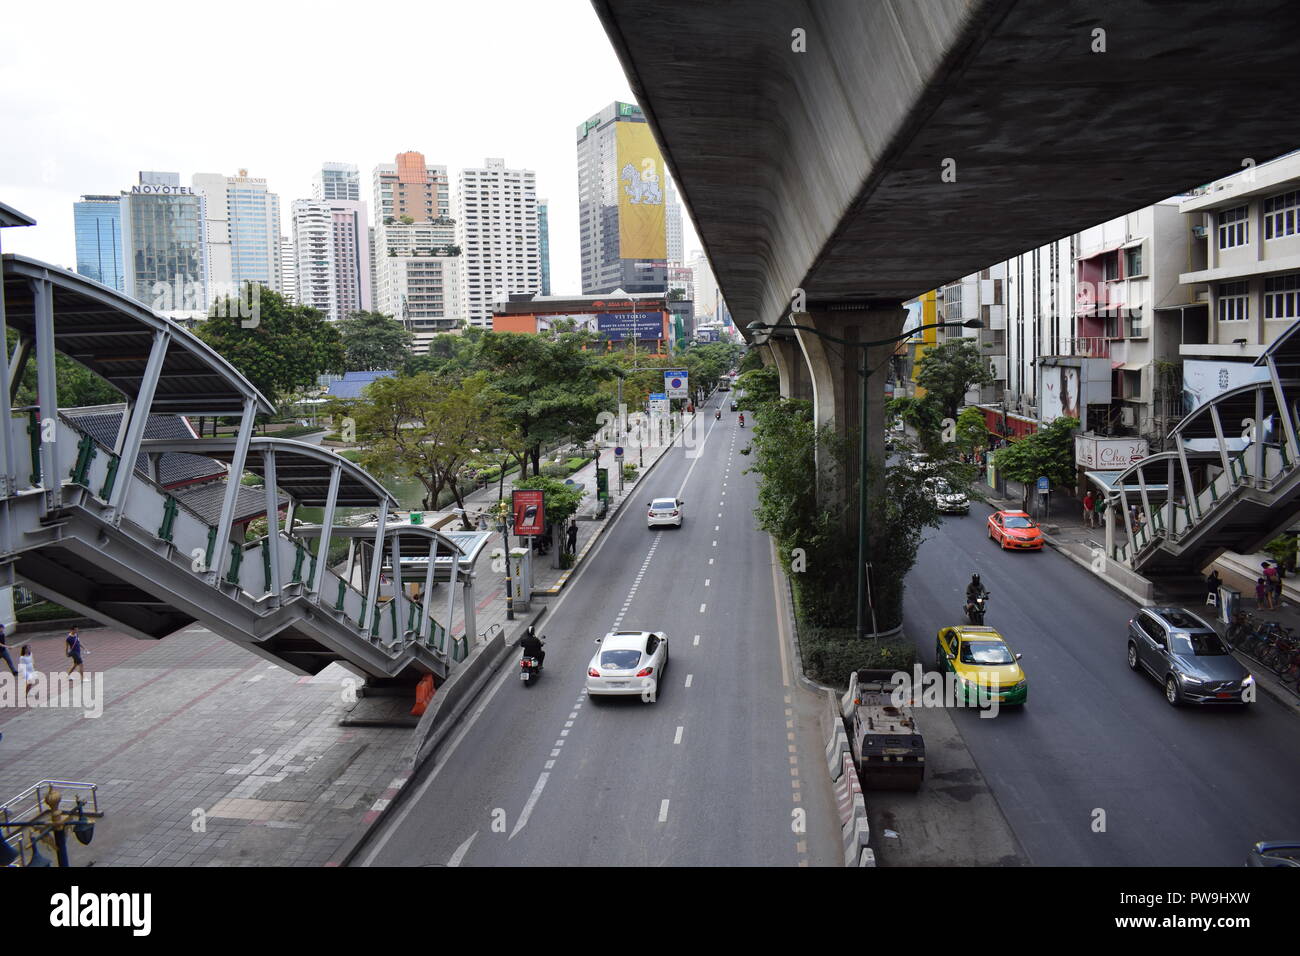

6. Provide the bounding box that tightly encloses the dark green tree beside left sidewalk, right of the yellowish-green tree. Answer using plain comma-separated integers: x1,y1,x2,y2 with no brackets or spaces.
480,332,615,479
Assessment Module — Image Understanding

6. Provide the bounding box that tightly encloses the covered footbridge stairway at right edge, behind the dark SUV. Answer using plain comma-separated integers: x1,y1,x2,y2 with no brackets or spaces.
1106,323,1300,576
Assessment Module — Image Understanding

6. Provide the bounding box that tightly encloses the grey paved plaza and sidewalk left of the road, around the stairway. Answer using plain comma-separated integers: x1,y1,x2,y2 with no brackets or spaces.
0,403,712,866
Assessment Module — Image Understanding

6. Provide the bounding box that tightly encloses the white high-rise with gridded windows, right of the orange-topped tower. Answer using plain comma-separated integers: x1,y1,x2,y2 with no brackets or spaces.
456,159,542,328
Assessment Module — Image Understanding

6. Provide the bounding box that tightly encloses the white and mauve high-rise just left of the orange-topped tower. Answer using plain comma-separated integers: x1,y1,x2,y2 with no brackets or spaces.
294,199,373,321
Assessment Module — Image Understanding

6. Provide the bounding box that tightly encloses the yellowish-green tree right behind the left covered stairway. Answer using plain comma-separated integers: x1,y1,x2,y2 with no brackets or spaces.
350,373,510,529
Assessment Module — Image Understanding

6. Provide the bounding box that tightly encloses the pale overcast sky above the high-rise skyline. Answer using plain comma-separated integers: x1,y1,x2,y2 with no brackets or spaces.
0,0,699,293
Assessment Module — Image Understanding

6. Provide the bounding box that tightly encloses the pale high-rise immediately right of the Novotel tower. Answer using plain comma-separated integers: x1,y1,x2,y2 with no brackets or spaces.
190,169,281,306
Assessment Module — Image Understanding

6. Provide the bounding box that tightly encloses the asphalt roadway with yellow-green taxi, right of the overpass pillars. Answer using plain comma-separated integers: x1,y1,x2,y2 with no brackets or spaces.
905,502,1300,866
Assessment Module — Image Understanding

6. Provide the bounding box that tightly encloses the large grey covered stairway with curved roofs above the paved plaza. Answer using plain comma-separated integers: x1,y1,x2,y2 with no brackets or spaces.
0,255,488,680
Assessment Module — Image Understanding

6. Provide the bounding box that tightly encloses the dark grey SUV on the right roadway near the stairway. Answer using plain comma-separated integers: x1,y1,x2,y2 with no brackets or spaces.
1128,607,1255,706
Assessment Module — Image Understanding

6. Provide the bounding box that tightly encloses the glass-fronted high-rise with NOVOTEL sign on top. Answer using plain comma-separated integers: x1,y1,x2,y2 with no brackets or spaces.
121,170,208,319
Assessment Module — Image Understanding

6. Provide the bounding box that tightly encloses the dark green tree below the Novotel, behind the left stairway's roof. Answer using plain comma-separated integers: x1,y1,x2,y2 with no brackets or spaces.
195,287,345,413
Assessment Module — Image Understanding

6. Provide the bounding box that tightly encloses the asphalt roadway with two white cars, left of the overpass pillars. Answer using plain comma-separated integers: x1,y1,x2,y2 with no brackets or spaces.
358,393,842,866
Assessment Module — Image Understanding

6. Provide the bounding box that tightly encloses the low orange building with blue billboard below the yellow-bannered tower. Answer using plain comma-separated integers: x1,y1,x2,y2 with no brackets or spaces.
491,295,672,352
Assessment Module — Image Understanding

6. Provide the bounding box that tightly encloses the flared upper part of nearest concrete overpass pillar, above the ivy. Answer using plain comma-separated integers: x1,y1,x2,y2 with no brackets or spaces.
793,306,907,512
